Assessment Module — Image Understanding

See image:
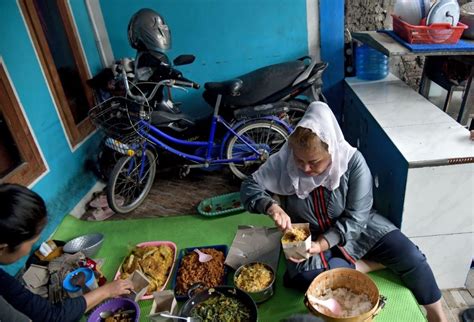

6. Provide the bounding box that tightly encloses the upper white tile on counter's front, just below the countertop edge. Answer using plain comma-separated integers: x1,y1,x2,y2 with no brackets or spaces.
402,163,474,237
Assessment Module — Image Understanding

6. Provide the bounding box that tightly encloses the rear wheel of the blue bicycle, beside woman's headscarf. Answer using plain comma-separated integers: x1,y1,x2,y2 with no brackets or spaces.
226,120,289,179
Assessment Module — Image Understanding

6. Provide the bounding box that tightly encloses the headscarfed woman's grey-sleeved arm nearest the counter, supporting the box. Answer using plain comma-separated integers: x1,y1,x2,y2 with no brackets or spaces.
323,152,373,250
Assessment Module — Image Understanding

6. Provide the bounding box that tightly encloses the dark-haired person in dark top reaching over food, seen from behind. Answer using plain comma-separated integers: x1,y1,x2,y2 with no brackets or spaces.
0,184,133,322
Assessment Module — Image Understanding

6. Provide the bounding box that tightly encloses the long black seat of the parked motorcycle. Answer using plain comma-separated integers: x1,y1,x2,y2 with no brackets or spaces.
203,60,307,107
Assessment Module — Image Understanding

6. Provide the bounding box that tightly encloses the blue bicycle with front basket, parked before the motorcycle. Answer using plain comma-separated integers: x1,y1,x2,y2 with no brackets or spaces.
89,70,292,213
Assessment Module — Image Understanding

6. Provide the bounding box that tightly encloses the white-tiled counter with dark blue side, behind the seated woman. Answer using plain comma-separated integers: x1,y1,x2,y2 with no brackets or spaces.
343,74,474,288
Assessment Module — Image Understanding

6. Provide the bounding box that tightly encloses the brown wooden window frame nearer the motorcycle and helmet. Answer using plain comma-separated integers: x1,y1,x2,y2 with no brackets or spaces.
19,0,95,147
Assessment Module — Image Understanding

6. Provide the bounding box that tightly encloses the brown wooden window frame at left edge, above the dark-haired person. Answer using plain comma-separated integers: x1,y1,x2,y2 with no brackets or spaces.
0,60,47,186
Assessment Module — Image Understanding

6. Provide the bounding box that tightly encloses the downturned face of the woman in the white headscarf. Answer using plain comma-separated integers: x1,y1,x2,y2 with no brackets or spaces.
293,146,331,177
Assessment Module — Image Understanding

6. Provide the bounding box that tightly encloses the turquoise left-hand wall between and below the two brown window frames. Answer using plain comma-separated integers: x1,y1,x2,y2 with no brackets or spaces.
0,0,101,272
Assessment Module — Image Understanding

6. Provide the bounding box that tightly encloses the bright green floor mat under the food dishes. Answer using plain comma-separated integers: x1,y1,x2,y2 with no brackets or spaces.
53,213,426,322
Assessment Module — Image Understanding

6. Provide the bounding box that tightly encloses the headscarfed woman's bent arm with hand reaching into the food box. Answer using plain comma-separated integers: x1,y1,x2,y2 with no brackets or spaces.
240,176,291,230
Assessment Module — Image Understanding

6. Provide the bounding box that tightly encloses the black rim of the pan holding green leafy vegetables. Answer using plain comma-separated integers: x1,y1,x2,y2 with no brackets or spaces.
179,286,258,322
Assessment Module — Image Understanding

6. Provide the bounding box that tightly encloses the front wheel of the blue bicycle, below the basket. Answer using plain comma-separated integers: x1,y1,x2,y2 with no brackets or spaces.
107,150,156,214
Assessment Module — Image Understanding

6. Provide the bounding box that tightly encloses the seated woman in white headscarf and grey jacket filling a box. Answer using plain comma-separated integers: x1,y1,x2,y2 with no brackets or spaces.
241,102,446,321
